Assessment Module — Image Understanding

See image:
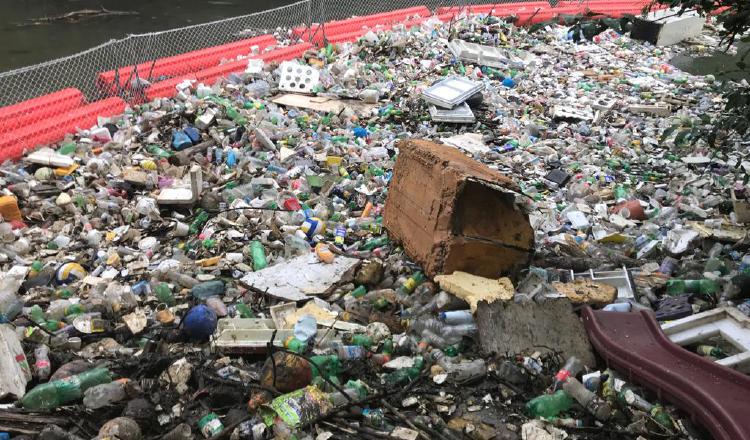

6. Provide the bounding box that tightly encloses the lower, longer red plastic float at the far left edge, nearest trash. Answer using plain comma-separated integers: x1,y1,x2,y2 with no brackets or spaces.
0,98,127,162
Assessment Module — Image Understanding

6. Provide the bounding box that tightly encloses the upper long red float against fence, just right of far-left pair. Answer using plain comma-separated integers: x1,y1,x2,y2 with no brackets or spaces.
97,35,277,95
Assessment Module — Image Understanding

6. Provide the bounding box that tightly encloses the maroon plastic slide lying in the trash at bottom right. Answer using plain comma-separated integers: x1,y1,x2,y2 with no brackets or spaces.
582,307,750,440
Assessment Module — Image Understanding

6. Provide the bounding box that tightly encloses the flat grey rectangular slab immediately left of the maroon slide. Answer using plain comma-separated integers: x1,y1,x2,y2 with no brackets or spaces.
476,299,596,366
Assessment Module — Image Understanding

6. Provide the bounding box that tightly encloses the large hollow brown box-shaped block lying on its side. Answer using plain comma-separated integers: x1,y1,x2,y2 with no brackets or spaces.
383,140,534,278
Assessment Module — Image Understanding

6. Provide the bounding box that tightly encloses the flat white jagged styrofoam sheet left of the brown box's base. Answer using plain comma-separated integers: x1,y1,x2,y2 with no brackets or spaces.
240,254,360,301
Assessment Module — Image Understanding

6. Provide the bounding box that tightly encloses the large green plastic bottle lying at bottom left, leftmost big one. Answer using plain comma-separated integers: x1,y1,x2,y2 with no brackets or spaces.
21,368,112,411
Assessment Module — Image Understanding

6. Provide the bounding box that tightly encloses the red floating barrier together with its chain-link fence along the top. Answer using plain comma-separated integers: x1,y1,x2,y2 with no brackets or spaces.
0,0,600,161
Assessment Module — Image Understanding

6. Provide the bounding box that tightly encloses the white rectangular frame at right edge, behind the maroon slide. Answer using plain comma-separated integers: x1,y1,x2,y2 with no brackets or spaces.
661,307,750,373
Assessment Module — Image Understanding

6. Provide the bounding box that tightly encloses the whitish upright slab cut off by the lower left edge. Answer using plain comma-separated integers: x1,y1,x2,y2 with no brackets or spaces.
0,324,31,399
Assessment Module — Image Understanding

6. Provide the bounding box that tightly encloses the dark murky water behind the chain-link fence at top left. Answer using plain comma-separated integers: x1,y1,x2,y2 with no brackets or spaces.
0,0,294,72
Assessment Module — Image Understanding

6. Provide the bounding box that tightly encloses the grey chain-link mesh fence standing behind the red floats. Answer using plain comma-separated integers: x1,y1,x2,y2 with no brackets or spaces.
0,0,600,106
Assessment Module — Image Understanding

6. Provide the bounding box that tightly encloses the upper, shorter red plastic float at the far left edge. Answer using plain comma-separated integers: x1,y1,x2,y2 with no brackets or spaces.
0,89,84,134
